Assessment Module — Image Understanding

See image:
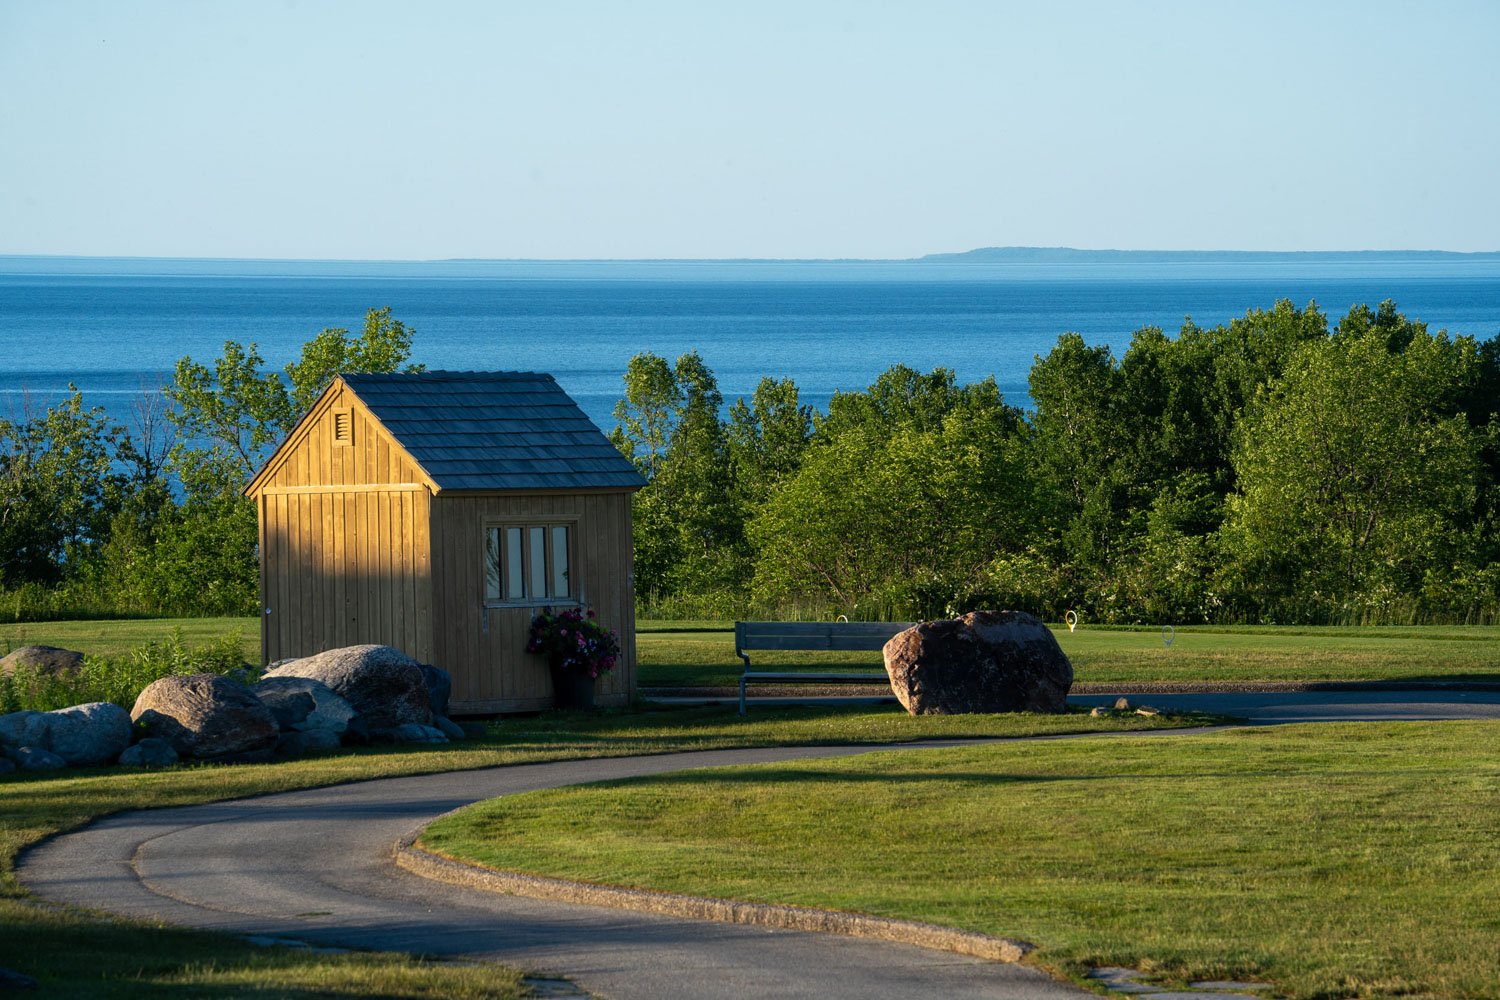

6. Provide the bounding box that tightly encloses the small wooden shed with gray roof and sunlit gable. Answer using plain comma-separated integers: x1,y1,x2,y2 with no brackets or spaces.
245,372,645,715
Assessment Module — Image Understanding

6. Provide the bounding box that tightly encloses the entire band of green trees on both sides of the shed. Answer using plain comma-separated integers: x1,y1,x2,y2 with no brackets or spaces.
0,301,1500,624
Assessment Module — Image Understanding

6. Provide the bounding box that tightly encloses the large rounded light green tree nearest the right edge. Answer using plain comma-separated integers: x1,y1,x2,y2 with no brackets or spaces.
1226,320,1481,619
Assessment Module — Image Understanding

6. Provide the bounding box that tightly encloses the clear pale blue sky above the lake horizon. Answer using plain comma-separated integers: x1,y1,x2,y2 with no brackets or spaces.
0,0,1500,259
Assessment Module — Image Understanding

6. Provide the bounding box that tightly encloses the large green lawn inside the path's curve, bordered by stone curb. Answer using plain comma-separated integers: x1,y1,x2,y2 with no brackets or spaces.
422,723,1500,999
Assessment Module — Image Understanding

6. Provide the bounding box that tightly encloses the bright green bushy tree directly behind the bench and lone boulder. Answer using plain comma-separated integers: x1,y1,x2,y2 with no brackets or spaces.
750,367,1032,616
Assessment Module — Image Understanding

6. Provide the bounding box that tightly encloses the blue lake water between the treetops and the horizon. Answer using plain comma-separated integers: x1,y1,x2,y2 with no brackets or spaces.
0,258,1500,430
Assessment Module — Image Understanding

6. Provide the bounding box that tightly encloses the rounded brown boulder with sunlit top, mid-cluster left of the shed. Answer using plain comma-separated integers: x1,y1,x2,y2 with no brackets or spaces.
131,673,279,760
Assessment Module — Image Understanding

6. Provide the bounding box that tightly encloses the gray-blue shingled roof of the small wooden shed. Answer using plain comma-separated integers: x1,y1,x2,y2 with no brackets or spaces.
344,372,645,490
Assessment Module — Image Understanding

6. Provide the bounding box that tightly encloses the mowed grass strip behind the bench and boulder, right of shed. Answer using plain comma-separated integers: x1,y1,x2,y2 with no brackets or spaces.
636,621,1500,687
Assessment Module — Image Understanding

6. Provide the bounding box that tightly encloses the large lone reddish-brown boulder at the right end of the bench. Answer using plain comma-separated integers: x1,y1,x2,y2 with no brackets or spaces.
885,612,1073,715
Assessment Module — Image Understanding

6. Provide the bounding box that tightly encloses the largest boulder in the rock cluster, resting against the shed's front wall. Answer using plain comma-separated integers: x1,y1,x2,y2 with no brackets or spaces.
266,645,432,730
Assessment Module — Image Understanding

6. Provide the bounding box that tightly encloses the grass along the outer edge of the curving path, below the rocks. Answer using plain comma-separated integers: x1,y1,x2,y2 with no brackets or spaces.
0,701,1217,999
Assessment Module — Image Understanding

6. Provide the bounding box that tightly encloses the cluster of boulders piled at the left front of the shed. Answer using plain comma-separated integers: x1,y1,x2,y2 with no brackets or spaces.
0,645,471,774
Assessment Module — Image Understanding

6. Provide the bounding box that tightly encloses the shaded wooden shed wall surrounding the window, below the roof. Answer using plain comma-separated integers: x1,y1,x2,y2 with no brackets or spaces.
432,492,636,714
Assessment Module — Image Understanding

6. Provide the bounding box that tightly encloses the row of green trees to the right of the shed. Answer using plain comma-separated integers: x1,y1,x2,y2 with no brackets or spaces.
614,301,1500,624
